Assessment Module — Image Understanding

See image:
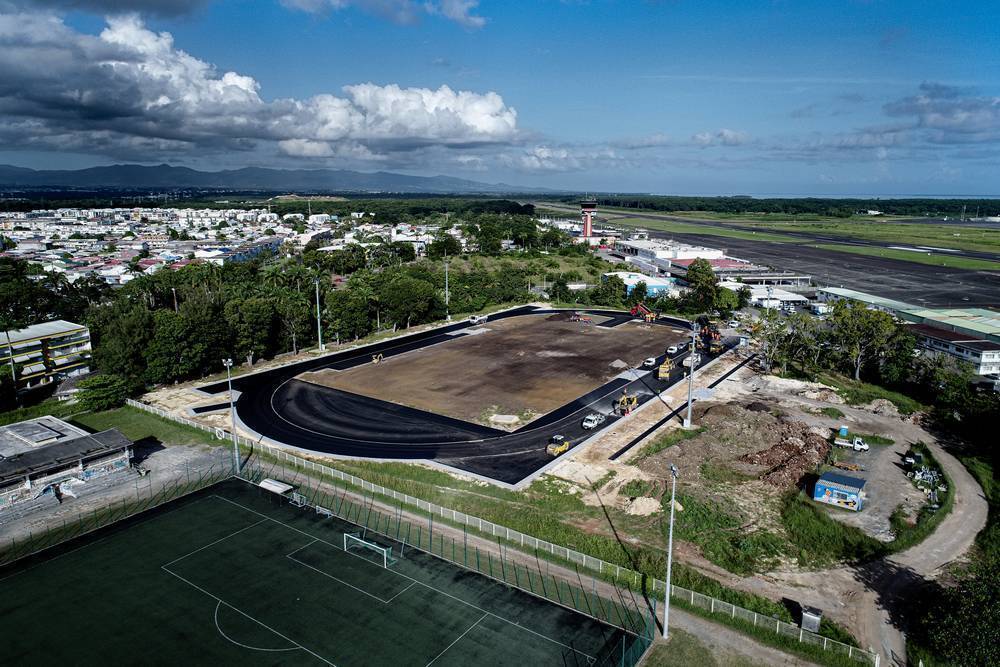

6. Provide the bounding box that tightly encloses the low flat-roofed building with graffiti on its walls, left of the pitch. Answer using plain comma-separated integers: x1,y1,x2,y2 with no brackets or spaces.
0,416,132,516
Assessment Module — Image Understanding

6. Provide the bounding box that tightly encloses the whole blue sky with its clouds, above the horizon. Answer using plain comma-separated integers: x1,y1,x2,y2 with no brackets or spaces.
0,0,1000,196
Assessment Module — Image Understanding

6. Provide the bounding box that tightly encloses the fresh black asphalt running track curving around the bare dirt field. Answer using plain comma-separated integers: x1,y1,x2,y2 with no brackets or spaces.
201,306,704,484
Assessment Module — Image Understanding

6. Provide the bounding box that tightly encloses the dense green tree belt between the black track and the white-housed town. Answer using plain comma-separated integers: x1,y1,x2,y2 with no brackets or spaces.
0,220,592,405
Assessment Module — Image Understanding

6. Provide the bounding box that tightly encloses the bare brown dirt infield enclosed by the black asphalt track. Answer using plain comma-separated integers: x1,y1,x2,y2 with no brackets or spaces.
301,313,684,426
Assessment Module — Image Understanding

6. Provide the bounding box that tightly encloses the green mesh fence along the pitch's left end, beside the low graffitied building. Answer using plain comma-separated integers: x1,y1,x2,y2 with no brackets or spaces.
0,461,233,566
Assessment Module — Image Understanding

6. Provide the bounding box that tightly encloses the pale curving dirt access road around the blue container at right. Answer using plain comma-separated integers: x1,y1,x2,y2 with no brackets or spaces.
686,371,988,664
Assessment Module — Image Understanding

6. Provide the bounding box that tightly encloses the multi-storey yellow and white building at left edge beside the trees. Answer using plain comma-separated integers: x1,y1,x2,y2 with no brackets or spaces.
0,320,90,388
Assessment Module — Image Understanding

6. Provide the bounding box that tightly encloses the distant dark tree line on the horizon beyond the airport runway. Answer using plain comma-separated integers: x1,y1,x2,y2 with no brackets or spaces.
561,195,1000,218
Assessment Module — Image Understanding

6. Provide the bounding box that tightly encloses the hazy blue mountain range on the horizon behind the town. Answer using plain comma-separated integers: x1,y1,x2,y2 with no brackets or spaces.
0,164,551,194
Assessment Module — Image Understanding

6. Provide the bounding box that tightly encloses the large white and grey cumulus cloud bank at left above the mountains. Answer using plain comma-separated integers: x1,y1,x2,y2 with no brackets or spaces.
0,12,518,160
